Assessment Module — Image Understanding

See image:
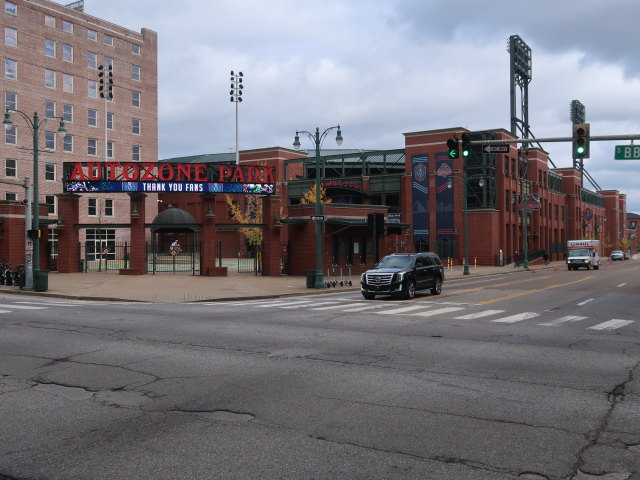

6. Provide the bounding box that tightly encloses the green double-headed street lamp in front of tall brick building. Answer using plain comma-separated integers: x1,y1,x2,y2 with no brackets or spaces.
2,108,67,290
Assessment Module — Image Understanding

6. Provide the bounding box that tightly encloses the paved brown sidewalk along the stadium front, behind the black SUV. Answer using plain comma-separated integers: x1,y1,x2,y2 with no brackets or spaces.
0,262,564,303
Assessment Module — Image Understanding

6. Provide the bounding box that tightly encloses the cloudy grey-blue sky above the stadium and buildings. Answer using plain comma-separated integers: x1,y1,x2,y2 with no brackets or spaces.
85,0,640,213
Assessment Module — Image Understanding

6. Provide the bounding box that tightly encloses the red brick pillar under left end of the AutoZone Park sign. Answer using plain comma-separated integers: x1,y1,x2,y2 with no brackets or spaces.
56,193,82,273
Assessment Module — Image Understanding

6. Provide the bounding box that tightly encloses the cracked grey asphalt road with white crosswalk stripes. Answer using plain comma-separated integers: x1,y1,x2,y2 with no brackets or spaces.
0,260,640,480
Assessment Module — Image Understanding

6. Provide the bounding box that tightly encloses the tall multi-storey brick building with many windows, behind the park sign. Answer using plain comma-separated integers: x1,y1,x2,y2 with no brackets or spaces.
0,0,158,262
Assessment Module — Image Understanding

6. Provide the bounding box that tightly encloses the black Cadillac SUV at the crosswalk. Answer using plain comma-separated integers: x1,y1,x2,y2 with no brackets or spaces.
360,252,444,300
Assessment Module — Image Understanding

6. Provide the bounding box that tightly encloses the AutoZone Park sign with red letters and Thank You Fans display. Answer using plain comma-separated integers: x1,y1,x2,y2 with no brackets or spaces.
62,162,276,195
